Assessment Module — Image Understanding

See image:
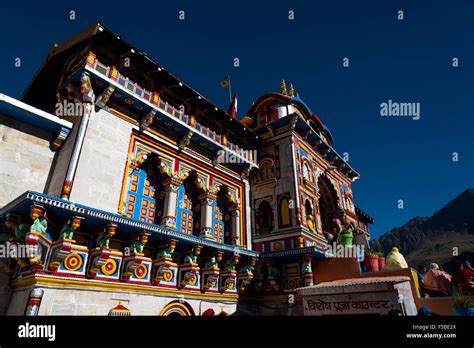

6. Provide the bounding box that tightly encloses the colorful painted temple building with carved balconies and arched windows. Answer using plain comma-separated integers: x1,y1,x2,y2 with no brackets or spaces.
0,23,382,315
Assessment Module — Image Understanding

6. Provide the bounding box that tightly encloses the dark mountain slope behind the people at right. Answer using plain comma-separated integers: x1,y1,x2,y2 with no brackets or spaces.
372,189,474,271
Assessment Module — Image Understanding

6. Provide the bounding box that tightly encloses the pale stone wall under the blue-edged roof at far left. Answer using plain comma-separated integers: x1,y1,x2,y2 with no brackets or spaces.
0,115,55,207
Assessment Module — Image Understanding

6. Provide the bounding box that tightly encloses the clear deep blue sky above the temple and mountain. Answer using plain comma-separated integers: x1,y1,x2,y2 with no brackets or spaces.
0,0,474,235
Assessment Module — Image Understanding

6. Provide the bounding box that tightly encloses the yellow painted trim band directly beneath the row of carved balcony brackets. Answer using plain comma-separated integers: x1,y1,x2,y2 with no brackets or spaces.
10,275,238,301
